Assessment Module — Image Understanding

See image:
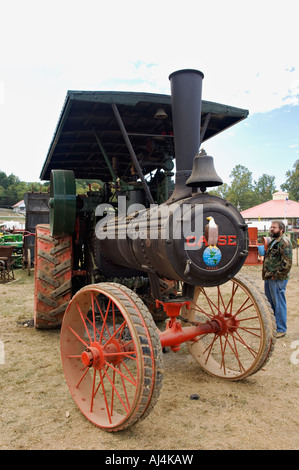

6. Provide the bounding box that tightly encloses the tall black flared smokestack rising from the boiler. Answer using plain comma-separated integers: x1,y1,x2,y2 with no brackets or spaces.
169,69,204,201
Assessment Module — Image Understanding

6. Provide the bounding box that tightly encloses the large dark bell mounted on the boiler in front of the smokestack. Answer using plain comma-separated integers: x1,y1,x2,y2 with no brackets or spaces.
186,154,223,192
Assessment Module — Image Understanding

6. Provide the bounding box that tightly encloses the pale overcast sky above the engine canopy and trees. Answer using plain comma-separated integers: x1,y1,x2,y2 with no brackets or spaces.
0,0,299,189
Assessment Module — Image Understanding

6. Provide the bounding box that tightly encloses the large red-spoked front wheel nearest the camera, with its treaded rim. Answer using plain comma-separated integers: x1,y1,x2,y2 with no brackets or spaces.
61,283,163,431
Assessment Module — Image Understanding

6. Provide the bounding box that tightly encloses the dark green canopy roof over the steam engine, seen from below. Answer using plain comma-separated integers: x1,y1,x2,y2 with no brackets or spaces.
40,91,248,181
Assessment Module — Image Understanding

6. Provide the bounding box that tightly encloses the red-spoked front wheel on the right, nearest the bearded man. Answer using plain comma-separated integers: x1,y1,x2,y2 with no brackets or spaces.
182,275,275,380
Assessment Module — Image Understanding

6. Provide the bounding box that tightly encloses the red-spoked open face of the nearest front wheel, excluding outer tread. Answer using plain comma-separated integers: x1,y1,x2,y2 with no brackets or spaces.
61,286,149,430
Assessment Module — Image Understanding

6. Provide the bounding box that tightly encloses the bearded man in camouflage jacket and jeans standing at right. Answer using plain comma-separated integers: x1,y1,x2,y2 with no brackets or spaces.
262,220,293,338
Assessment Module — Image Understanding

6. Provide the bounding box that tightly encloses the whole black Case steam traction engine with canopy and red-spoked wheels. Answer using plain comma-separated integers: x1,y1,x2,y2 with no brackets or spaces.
34,70,275,431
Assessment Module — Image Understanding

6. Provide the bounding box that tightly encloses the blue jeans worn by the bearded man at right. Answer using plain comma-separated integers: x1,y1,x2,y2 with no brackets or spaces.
265,279,288,333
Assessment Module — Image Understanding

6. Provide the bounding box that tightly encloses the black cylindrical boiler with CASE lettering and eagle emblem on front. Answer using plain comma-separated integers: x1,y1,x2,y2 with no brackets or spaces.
96,193,248,286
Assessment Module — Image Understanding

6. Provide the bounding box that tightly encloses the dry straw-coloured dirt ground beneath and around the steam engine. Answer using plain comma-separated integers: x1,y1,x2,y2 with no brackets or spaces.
0,262,299,450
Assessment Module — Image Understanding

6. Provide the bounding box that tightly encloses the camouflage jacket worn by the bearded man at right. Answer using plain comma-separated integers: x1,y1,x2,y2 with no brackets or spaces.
262,234,293,280
